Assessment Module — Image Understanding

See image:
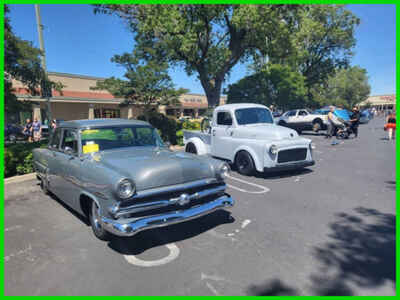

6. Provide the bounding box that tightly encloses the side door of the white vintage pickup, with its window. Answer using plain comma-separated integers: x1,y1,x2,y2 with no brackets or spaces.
211,111,233,159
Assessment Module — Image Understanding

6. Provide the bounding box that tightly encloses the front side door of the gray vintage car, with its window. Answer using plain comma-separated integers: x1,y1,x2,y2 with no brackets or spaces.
57,128,82,209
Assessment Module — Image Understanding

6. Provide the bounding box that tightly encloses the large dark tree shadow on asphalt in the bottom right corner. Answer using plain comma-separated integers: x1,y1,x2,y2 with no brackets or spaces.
311,207,396,295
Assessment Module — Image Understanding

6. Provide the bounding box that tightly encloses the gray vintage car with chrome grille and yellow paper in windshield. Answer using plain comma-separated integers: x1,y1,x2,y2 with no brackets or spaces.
33,119,234,240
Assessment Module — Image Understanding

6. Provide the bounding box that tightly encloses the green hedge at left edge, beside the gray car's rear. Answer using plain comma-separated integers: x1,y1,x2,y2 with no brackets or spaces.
4,141,47,177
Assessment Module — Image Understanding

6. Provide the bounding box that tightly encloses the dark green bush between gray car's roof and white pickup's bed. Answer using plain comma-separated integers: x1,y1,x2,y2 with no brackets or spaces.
138,112,178,145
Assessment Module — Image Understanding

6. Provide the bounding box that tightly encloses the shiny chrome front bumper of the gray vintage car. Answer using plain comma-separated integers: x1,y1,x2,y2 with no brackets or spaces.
101,194,235,237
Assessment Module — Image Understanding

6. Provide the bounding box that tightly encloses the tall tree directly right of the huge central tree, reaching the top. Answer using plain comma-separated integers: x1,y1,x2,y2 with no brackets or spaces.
287,5,360,96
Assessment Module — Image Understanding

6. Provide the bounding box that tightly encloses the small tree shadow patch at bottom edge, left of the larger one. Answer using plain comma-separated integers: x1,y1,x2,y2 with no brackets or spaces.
246,279,299,296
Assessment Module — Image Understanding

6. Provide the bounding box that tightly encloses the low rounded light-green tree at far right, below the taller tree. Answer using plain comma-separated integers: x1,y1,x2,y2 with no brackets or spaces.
313,66,371,108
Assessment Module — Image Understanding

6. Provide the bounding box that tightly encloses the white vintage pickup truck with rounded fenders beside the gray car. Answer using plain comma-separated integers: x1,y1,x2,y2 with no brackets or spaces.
183,103,314,175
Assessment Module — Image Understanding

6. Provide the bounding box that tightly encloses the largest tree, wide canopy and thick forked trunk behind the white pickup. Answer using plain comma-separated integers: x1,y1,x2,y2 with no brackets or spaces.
95,5,299,106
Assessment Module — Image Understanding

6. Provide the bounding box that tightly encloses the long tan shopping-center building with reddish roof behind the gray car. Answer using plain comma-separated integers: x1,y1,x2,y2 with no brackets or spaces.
5,72,226,123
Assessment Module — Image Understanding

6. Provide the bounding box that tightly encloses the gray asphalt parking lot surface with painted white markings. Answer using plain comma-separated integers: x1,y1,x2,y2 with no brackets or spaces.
4,118,396,295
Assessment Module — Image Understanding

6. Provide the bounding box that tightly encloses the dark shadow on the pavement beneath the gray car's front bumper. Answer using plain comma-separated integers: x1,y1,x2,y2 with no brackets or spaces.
108,210,235,255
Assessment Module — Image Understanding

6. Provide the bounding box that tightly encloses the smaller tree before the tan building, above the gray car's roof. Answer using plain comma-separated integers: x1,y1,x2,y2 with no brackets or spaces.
92,53,187,120
